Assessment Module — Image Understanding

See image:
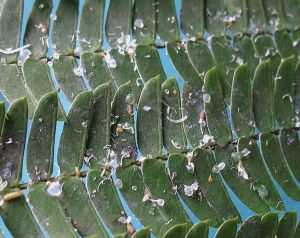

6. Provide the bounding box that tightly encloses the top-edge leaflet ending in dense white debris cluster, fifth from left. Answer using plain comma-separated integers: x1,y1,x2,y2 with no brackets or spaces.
105,0,132,47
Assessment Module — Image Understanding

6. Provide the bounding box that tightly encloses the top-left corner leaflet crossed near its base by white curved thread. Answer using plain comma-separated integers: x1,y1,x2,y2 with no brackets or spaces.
0,0,24,64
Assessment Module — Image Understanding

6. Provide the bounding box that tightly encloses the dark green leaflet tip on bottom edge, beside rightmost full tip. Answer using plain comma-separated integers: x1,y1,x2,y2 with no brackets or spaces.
260,212,278,238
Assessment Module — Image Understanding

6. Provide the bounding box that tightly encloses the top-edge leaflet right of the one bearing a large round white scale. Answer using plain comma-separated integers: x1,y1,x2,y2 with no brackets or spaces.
156,0,179,42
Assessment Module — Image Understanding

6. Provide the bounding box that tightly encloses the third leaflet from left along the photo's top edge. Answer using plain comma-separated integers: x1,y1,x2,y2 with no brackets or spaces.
52,0,79,55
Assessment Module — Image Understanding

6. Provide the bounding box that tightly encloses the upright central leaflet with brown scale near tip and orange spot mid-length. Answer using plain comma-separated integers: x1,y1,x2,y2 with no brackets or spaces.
110,82,137,165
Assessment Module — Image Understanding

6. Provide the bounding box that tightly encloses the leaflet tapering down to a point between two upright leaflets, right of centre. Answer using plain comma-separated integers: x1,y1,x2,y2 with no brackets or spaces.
211,37,237,101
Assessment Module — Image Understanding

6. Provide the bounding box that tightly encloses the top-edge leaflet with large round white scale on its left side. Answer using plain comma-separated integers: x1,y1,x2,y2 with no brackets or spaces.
132,0,156,45
